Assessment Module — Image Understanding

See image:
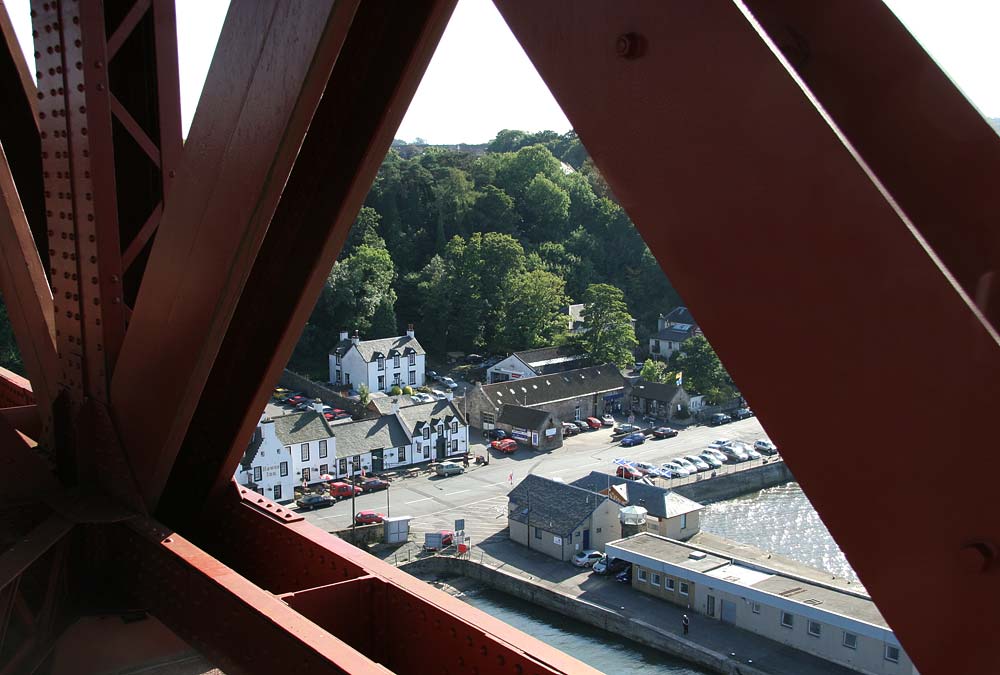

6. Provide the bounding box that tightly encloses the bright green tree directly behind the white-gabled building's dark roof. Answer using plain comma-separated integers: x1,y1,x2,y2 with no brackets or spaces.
498,270,567,351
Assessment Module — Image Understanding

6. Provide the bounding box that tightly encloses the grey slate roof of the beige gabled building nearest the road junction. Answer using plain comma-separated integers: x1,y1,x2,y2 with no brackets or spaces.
507,474,607,537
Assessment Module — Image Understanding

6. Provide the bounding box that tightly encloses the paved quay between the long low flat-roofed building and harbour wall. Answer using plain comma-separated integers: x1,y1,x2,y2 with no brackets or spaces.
382,533,856,675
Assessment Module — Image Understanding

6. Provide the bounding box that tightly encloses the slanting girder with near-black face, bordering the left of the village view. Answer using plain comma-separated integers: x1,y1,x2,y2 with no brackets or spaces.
159,0,455,526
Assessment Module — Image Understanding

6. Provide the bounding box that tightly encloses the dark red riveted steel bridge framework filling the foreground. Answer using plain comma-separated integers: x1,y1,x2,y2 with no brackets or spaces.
0,0,1000,673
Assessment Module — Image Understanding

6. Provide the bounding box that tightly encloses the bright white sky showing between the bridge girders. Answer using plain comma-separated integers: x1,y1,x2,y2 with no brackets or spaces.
6,0,1000,143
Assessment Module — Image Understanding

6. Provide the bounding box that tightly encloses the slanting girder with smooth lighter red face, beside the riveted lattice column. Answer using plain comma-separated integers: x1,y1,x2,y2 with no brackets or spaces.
112,0,357,507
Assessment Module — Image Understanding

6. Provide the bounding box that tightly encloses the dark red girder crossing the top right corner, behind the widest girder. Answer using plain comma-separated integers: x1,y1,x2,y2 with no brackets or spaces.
746,0,1000,328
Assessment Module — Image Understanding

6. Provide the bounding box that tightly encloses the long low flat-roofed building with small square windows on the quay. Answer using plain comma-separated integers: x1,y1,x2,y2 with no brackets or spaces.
605,532,917,675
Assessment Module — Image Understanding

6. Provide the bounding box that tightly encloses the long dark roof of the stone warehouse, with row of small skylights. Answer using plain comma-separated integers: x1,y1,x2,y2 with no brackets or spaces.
483,364,625,408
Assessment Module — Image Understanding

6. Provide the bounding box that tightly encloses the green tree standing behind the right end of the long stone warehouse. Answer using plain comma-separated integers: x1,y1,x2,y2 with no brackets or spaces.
577,284,639,368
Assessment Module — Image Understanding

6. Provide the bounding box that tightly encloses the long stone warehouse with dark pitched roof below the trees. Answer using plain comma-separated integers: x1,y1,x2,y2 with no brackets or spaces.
465,364,625,431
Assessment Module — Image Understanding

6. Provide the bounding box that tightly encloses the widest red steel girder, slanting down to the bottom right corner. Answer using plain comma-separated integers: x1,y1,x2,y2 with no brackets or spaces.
497,0,1000,673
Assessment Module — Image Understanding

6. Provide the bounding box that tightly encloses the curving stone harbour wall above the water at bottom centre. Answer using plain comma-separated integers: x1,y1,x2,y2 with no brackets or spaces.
400,556,767,675
